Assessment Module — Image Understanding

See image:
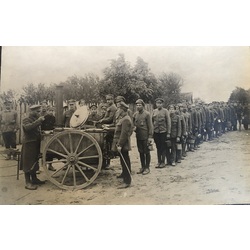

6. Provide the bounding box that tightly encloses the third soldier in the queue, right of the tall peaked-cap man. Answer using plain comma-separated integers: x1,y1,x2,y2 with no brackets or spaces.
168,105,182,166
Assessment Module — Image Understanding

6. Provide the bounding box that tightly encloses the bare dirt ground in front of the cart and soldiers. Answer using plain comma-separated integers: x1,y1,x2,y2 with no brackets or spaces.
0,130,250,205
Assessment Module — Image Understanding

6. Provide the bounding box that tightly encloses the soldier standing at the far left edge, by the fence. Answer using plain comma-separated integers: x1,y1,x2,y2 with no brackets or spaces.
0,101,19,160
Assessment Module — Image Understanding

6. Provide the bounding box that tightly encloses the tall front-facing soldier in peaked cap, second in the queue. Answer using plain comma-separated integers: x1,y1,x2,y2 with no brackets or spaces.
152,98,171,168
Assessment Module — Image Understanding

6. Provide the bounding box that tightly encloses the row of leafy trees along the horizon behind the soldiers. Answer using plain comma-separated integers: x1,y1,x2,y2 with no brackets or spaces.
0,54,250,105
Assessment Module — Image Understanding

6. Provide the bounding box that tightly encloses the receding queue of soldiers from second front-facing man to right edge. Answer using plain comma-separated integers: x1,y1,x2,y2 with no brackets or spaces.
152,98,249,168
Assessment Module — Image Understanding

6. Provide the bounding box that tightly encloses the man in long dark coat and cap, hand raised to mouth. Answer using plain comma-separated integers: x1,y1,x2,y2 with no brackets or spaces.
21,105,45,190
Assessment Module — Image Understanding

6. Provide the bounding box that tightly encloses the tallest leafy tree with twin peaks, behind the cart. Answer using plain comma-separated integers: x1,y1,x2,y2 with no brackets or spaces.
99,54,157,103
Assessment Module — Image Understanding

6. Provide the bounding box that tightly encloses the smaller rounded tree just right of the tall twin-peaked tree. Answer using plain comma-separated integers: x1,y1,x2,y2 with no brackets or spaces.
159,72,183,106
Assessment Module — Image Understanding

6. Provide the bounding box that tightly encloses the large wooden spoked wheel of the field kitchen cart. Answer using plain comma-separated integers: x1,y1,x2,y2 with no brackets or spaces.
43,130,102,190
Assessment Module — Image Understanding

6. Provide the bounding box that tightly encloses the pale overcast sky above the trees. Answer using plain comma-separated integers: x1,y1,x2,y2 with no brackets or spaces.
1,46,250,102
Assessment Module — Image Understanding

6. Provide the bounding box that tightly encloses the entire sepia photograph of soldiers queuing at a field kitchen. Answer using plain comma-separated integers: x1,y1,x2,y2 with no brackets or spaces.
0,46,250,205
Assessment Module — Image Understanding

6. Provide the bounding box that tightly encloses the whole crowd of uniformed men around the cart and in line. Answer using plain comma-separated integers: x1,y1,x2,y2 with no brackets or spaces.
0,94,250,190
